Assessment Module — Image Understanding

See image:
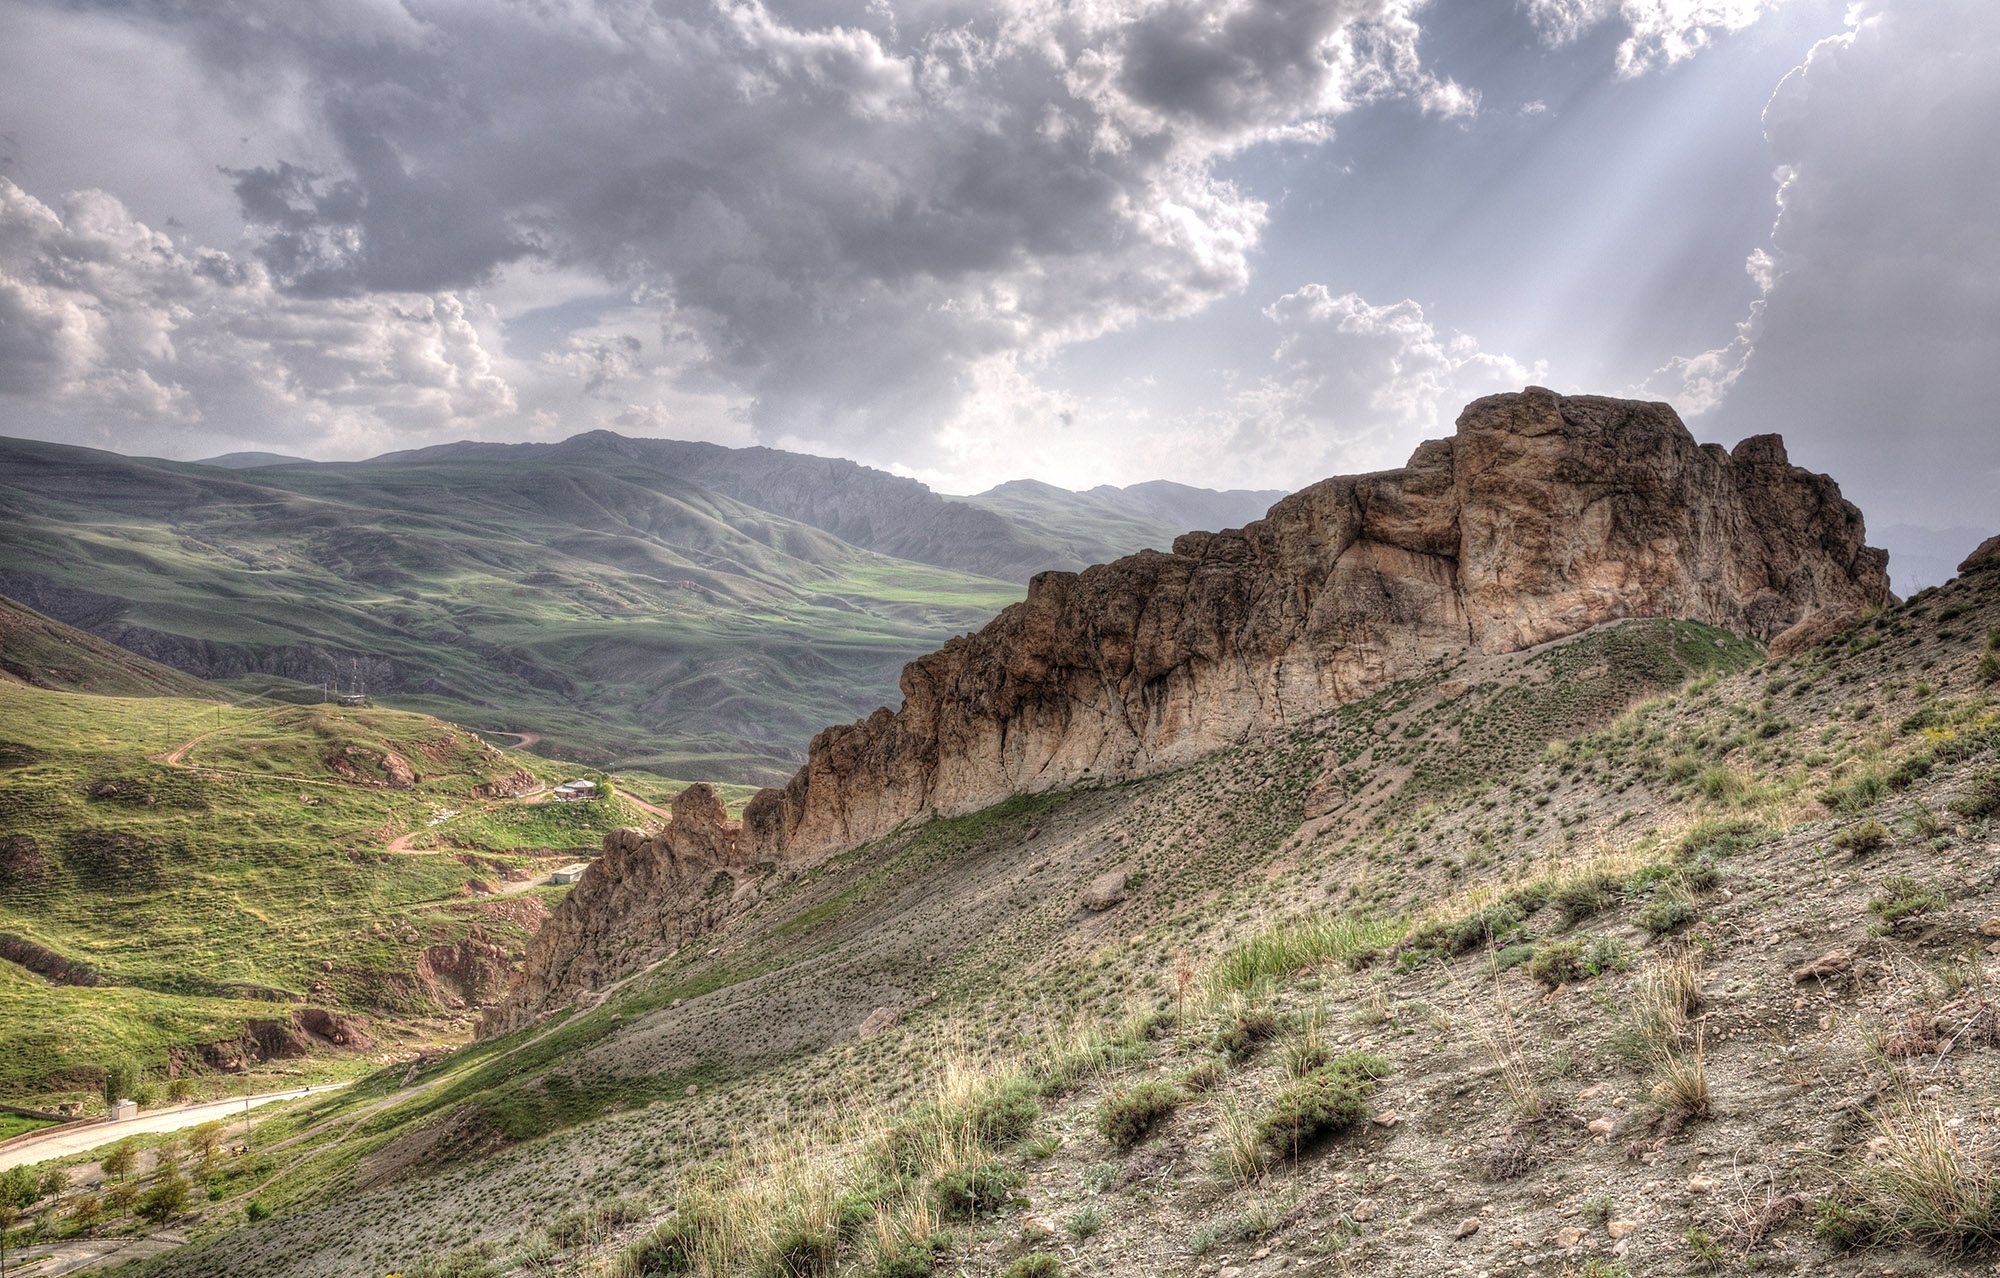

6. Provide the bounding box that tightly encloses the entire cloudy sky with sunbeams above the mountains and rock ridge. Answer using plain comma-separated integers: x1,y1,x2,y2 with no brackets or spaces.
0,0,2000,526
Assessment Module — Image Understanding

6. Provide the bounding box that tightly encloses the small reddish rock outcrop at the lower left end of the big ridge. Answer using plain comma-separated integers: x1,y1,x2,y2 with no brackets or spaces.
480,784,754,1038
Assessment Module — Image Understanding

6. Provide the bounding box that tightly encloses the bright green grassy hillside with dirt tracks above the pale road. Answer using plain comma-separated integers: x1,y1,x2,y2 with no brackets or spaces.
0,684,672,1100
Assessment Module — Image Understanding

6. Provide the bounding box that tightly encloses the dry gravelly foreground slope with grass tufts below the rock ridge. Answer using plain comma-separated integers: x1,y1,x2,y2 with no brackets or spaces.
78,572,2000,1278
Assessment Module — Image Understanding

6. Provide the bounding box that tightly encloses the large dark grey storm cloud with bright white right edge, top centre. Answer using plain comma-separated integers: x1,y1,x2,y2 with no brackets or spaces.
3,0,1466,458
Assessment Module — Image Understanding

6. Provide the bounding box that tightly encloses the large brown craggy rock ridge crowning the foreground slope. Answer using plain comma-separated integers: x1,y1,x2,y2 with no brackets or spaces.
744,388,1892,860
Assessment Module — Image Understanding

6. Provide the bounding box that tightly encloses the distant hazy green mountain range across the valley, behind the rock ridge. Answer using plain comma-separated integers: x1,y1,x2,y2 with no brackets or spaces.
0,432,1280,782
